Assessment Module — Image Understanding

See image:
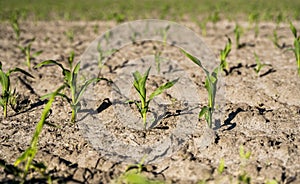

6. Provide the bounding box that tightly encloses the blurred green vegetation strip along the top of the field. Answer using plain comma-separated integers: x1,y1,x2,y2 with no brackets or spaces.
0,0,300,22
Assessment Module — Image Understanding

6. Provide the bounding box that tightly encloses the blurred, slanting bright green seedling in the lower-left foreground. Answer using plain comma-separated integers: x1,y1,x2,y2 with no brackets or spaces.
14,86,64,183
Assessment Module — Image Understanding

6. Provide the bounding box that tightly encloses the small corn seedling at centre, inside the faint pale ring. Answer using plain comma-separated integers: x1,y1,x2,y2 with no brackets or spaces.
128,68,179,128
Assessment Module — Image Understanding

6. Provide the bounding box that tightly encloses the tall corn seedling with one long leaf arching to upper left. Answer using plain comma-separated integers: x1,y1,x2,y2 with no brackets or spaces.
182,50,221,128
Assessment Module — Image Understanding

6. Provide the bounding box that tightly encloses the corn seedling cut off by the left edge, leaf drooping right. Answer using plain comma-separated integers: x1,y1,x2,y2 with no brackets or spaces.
0,62,33,118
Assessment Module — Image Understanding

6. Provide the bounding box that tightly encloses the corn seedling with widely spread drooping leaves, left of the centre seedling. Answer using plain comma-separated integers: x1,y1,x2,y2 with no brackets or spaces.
35,52,107,123
